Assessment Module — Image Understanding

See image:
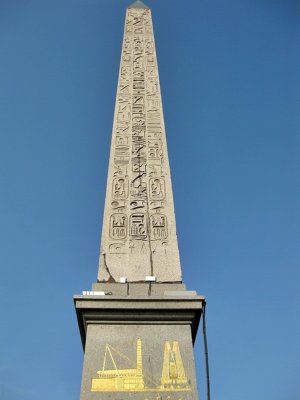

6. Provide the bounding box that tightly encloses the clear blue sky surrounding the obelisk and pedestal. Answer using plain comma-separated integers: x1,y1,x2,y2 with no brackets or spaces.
0,0,300,400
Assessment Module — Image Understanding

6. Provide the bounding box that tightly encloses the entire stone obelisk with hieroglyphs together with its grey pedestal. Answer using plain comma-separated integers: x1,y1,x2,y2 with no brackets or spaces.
74,0,204,400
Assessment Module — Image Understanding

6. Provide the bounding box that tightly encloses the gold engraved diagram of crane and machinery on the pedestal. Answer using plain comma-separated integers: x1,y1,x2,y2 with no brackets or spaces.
91,338,192,392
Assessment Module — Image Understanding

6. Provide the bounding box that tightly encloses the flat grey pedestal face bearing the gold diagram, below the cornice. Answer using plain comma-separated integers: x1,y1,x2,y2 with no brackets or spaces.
81,325,197,400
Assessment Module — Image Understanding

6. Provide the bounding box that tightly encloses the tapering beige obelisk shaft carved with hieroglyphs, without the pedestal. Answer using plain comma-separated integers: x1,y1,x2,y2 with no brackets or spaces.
98,3,181,282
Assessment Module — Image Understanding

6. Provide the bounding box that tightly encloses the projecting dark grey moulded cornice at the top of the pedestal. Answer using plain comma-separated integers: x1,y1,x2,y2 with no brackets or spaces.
74,295,204,348
